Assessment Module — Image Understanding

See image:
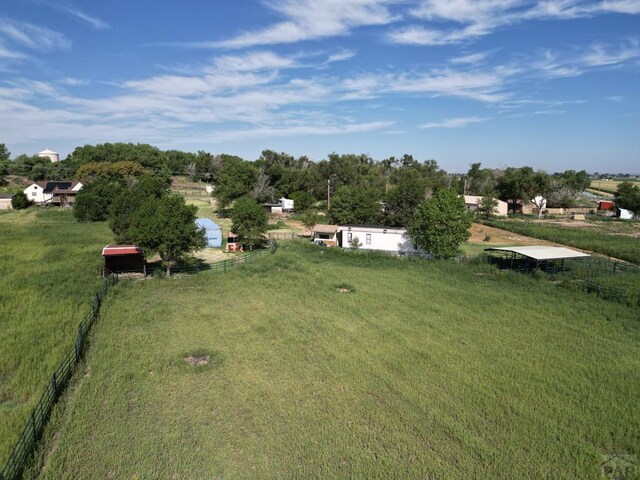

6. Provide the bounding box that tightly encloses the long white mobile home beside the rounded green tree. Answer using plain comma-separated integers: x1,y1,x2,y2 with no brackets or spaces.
338,225,416,253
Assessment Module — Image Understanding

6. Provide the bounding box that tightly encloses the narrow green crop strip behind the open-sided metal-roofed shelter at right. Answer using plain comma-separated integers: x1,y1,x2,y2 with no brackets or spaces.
483,220,640,264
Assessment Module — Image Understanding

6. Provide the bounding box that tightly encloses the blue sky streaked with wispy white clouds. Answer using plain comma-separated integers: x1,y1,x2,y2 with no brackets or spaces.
0,0,640,173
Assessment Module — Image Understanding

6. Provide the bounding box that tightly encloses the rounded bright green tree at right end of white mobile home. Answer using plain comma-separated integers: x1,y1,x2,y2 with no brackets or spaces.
407,188,473,257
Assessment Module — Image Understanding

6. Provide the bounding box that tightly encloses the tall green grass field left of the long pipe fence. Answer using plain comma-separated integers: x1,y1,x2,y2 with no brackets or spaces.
0,208,111,462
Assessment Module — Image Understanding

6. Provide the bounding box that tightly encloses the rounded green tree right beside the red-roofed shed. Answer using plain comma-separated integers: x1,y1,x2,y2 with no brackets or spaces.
129,194,206,275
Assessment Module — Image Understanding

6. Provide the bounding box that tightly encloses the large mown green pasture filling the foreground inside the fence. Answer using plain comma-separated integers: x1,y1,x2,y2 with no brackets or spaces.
33,243,640,479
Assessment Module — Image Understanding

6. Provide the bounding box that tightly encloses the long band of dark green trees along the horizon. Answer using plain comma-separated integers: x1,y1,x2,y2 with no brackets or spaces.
0,143,640,259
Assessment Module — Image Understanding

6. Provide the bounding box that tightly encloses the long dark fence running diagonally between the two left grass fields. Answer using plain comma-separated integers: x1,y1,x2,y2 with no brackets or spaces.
0,275,118,480
